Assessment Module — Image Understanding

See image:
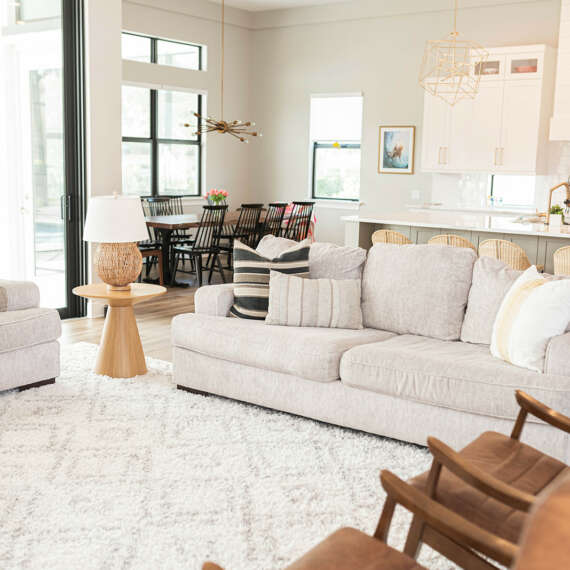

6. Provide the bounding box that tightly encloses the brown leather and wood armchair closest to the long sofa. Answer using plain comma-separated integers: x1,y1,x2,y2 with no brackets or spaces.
377,390,570,567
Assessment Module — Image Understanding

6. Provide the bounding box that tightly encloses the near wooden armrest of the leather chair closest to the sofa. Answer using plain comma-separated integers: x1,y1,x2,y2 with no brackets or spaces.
428,437,536,512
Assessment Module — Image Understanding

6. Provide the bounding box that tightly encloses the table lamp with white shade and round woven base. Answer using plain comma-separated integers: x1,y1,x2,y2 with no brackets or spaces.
83,194,148,291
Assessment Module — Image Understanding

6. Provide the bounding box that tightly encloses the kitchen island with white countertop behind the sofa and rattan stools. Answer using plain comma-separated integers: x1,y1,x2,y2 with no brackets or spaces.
342,210,570,273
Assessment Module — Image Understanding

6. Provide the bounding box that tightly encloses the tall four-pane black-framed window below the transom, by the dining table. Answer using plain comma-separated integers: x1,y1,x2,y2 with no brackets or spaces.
122,85,202,196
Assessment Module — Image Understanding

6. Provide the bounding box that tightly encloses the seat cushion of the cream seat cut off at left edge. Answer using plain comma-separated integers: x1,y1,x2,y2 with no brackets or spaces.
0,308,61,353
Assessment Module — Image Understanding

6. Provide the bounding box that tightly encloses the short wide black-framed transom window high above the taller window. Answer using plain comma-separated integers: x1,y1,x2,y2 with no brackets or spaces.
121,32,204,70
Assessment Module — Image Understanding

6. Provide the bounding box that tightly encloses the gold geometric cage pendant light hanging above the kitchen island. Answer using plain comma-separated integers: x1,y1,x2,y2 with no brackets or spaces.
419,0,489,105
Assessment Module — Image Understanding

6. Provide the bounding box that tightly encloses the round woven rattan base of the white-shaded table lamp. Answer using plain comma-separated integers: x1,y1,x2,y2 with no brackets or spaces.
95,242,142,291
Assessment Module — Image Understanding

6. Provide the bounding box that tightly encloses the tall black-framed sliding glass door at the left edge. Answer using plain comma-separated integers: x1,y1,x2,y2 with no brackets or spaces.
0,0,84,316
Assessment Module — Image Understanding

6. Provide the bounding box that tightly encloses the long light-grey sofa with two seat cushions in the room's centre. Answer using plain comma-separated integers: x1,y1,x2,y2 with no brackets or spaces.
172,245,570,461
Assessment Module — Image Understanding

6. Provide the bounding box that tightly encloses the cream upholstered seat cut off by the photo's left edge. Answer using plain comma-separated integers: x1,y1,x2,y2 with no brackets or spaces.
0,280,61,392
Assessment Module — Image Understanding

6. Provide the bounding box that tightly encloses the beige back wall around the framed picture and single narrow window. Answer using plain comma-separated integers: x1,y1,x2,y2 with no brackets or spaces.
248,0,560,243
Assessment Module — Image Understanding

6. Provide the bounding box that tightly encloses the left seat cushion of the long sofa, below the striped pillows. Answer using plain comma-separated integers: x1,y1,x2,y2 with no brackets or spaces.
172,313,394,382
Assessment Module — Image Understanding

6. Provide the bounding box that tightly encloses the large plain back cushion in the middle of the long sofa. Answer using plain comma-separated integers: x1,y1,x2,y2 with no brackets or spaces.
362,243,476,340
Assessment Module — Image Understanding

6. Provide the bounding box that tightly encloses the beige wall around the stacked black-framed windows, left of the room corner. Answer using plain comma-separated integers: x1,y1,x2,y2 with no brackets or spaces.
122,0,254,217
